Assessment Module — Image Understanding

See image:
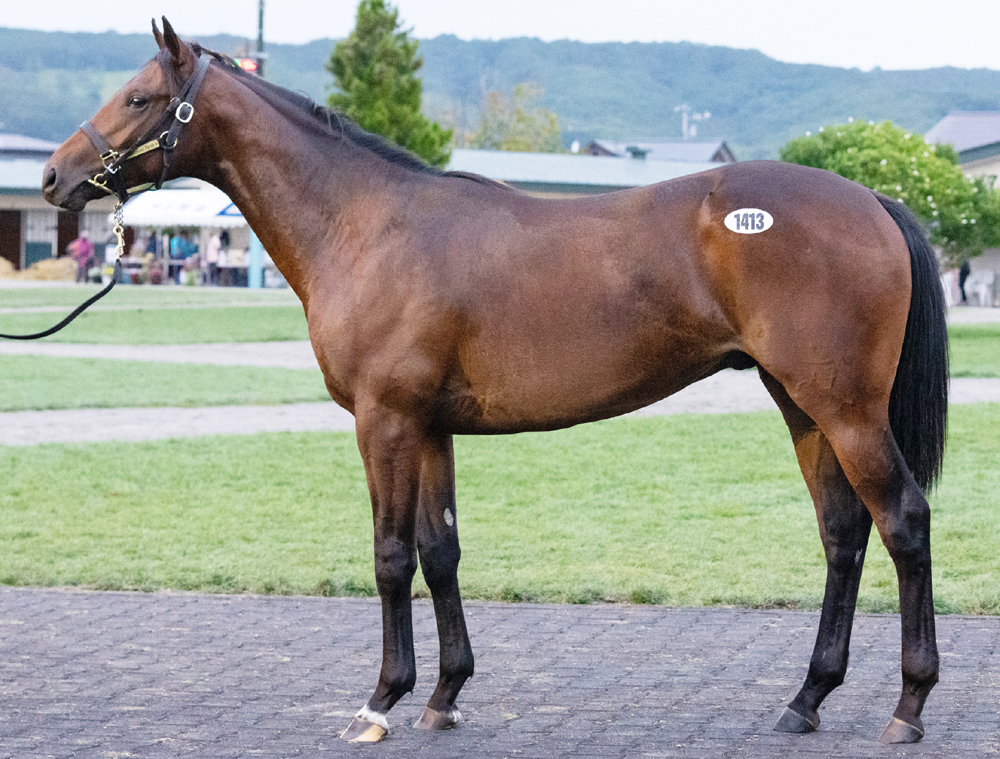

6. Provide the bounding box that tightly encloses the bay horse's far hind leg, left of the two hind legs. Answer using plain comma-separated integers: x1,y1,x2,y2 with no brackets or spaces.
761,370,872,733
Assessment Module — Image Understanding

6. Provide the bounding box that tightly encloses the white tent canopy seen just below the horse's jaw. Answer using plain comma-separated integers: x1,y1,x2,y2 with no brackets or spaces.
113,185,247,229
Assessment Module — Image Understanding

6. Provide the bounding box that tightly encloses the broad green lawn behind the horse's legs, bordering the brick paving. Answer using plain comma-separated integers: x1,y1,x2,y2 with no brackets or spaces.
0,404,1000,614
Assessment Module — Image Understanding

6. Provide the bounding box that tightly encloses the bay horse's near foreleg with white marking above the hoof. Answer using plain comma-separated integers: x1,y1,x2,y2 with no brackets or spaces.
340,412,426,742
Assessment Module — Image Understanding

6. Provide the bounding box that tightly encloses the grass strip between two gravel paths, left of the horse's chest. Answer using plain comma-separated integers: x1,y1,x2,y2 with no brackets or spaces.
0,356,330,411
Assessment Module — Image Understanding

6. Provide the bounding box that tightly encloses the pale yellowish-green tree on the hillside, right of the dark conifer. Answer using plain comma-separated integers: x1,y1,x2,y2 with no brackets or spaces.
469,82,563,153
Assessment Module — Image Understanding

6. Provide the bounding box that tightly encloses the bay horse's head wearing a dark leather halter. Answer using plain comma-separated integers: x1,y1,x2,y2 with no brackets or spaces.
42,18,208,211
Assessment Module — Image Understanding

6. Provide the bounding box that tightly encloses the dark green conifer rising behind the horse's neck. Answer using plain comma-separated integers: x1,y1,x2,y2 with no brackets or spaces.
326,0,451,166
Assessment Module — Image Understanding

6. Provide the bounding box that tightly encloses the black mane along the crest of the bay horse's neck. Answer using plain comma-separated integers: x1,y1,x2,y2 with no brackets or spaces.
192,42,507,187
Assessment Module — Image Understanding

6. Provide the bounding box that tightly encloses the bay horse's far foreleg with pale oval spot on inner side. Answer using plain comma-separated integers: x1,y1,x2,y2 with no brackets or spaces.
414,436,473,730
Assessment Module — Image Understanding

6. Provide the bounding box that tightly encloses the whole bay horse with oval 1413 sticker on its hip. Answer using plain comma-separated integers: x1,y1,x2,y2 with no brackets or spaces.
43,19,948,742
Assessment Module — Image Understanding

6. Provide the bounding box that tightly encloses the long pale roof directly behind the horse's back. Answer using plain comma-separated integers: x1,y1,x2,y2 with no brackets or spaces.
448,149,718,193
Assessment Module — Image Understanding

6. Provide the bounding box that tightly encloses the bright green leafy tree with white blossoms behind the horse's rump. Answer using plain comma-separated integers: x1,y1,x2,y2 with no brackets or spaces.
781,121,1000,266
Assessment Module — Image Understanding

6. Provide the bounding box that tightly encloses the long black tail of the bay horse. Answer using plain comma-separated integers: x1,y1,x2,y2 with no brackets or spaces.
875,193,948,490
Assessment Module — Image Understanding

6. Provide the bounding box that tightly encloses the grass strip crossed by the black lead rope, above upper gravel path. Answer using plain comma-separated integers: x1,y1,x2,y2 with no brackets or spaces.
0,306,309,345
